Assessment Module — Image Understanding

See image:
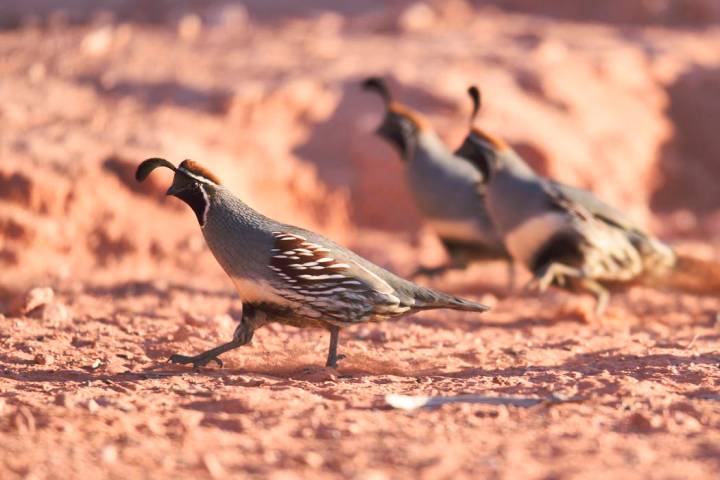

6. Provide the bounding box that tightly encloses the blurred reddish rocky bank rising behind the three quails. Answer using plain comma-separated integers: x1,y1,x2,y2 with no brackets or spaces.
0,0,720,288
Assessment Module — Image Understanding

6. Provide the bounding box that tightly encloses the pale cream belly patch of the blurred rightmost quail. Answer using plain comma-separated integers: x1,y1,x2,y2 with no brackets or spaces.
505,212,570,267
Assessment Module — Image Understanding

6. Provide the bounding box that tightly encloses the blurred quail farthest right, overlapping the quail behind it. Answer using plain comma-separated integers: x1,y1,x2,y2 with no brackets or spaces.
456,86,677,315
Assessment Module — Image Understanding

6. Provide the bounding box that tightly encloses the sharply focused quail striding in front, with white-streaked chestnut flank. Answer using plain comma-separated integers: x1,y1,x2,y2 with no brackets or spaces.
135,158,488,368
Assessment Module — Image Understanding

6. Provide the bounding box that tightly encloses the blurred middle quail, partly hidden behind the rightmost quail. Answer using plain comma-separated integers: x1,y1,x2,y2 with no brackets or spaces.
363,77,513,284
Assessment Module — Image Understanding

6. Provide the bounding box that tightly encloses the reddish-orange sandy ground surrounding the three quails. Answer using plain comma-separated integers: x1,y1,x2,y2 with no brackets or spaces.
0,2,720,479
